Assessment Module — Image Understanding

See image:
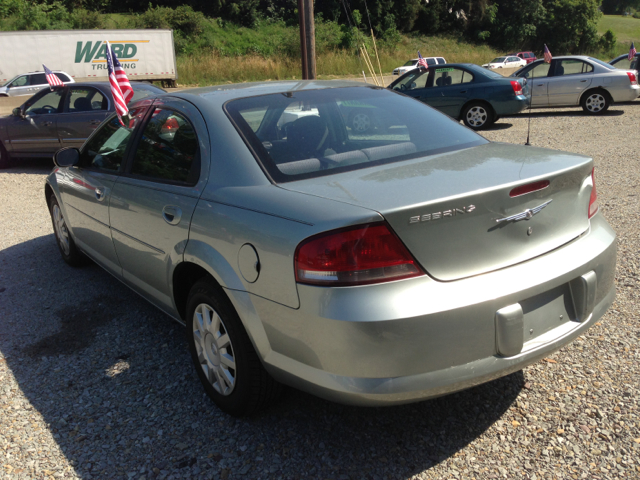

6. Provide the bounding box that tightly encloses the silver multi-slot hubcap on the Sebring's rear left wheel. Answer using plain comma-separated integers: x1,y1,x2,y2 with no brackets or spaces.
193,303,236,395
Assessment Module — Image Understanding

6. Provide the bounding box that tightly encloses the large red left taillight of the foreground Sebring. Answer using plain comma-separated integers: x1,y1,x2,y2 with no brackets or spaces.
295,223,423,286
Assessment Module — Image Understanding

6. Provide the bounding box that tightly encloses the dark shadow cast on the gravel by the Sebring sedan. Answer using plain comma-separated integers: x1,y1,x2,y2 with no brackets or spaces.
0,235,524,480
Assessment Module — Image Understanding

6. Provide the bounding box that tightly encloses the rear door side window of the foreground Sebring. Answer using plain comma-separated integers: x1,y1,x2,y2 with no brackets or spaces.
131,108,200,184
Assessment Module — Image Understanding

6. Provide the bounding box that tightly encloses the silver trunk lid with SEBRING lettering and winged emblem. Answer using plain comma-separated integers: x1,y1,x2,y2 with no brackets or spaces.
280,143,593,280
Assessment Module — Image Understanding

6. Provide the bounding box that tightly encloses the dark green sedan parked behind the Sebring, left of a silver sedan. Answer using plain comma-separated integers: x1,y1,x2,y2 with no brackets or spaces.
388,63,529,130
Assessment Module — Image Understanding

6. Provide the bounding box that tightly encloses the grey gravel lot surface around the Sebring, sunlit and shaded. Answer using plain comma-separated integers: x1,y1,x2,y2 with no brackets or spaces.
0,101,640,479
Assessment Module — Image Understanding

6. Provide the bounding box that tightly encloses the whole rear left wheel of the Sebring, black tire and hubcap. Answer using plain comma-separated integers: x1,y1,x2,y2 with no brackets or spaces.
185,280,281,417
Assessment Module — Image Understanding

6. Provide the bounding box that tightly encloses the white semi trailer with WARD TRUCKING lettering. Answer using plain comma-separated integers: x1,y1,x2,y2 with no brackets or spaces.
0,30,178,87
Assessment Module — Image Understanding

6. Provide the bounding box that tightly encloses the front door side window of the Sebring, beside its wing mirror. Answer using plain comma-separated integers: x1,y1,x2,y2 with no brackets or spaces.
79,108,146,173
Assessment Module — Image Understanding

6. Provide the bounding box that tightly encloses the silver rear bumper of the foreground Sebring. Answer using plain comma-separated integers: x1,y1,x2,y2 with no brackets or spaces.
241,214,616,406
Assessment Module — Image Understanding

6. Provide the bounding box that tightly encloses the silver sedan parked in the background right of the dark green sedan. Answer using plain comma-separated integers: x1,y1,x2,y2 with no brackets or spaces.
511,56,640,114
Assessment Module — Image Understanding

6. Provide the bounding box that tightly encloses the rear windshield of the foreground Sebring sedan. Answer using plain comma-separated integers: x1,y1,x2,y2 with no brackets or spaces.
225,87,487,182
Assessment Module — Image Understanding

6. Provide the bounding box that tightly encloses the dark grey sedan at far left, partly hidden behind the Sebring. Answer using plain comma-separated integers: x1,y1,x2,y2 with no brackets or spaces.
0,82,165,168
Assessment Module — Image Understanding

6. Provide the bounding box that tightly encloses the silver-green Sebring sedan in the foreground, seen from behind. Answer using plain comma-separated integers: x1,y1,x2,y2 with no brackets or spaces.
45,81,616,415
